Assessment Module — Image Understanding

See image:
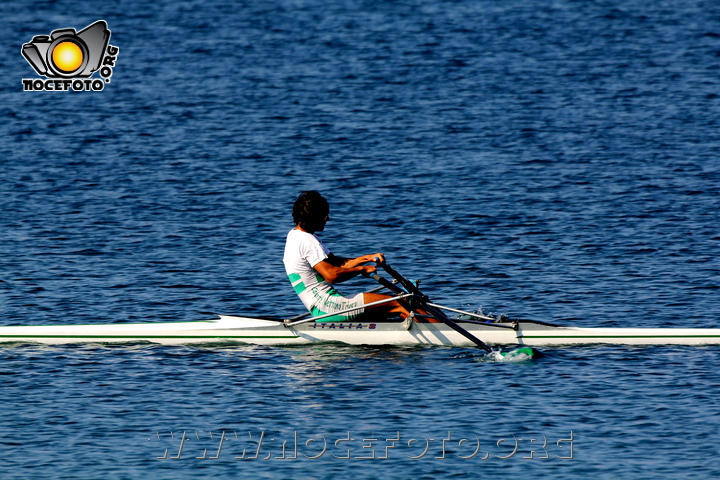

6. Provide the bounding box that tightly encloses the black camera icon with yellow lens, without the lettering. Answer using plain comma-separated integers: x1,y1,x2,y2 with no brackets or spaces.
22,20,110,78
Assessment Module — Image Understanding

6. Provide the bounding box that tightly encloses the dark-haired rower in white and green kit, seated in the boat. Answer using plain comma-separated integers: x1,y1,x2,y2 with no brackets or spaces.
283,191,410,322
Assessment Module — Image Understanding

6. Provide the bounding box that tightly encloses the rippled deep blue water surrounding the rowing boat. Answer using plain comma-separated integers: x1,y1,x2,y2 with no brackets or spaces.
0,0,720,479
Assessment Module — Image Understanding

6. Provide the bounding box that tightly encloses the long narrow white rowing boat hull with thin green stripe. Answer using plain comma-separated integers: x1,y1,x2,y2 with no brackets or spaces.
0,315,720,346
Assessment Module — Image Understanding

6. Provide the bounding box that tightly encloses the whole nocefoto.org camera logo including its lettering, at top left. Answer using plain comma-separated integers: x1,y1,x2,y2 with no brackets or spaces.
22,20,120,91
